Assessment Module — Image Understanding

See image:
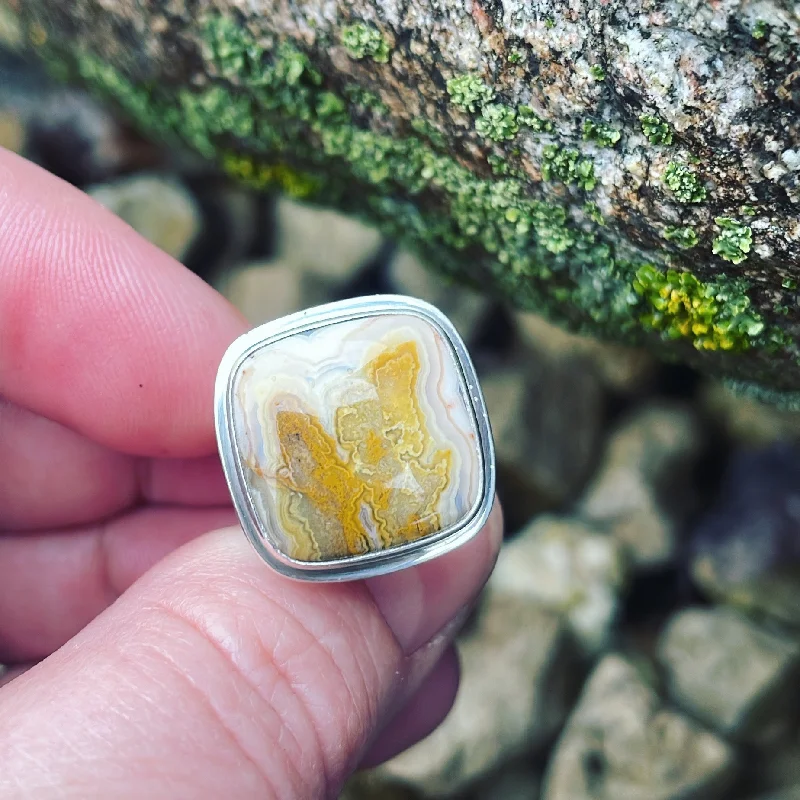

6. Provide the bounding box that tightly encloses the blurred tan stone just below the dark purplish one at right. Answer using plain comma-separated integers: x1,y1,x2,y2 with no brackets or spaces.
658,608,800,744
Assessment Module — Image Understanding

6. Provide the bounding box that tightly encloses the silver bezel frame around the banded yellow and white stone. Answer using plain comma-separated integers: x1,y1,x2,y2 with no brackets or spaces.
214,295,495,581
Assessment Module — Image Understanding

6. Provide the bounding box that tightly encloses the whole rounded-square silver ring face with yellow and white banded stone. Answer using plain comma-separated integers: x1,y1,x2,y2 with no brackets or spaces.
214,295,495,581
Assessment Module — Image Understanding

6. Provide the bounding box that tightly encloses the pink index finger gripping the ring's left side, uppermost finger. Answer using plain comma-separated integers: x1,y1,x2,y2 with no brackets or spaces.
0,148,247,456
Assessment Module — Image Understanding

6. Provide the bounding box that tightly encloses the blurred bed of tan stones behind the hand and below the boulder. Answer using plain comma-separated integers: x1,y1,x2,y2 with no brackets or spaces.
0,42,800,800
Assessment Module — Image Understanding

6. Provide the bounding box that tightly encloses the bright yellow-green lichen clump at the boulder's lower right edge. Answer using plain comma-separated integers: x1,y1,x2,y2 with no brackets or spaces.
633,265,765,352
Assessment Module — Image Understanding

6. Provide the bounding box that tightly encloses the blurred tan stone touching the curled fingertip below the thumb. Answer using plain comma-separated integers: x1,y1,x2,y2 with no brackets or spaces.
380,591,575,797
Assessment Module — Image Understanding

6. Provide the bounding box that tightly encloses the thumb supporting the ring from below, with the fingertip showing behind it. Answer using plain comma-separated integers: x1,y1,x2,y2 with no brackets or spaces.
0,508,502,800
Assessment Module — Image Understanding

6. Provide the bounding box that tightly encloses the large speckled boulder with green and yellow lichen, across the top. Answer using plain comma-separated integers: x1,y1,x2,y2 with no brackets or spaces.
10,0,800,394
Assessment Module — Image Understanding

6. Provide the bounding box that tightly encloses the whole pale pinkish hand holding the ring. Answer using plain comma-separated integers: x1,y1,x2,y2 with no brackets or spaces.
0,149,502,800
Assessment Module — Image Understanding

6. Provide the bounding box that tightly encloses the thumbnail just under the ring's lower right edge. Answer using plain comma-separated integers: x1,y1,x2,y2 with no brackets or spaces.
366,502,503,655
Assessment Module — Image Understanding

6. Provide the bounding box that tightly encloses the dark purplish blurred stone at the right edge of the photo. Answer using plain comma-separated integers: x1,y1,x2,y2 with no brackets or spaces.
691,443,800,627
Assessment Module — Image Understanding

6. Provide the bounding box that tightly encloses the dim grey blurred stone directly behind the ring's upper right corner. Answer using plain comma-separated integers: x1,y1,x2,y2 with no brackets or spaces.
388,250,490,343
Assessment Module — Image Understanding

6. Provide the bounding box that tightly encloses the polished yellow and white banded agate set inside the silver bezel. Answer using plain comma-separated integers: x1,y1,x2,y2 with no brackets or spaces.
233,313,484,562
